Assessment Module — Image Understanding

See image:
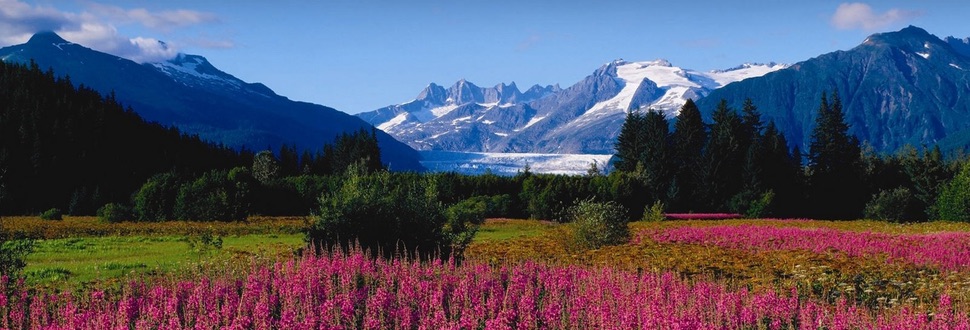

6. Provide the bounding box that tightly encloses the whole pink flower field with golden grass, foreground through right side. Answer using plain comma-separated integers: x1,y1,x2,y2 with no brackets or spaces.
0,219,970,329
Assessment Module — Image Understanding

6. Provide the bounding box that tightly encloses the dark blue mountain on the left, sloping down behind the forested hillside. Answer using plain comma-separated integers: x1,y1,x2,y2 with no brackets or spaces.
0,32,423,170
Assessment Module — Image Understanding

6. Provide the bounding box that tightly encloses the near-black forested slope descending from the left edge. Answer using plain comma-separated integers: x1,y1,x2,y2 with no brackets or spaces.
0,63,251,214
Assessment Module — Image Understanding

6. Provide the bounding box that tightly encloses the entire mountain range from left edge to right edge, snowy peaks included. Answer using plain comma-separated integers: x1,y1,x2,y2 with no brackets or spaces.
0,26,970,174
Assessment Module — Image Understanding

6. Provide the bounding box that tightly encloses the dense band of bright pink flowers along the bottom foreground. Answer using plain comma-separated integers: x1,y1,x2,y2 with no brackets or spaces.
0,246,970,329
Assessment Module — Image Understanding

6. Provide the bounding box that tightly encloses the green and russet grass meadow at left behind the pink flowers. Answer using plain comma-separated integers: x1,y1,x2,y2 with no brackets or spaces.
13,217,305,288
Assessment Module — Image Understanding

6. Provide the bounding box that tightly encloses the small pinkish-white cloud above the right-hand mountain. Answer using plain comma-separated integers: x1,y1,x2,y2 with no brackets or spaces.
830,2,922,31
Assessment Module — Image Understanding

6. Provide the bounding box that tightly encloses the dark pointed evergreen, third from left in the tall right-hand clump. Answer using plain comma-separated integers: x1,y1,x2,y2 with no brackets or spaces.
669,99,707,211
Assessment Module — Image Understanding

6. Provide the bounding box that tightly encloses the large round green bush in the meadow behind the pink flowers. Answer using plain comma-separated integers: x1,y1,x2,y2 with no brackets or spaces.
307,166,451,256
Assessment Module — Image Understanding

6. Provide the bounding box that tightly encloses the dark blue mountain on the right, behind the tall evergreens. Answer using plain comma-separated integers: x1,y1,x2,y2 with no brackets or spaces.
698,26,970,153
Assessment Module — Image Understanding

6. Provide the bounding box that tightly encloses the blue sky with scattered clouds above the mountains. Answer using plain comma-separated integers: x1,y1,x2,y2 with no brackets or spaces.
0,0,970,113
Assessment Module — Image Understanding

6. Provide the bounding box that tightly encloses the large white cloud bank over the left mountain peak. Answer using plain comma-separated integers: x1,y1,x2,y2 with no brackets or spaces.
0,0,226,63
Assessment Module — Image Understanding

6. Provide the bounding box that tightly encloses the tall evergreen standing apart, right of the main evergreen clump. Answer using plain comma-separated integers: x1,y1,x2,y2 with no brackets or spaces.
808,92,868,219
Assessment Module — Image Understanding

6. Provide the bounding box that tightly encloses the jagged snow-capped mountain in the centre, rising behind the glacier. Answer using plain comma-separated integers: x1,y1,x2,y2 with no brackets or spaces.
357,60,786,154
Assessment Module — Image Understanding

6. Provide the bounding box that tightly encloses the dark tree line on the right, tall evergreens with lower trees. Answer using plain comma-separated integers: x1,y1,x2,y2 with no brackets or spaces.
614,92,970,221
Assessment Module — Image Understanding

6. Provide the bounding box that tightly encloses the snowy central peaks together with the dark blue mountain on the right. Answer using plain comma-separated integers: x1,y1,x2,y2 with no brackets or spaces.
358,26,970,154
